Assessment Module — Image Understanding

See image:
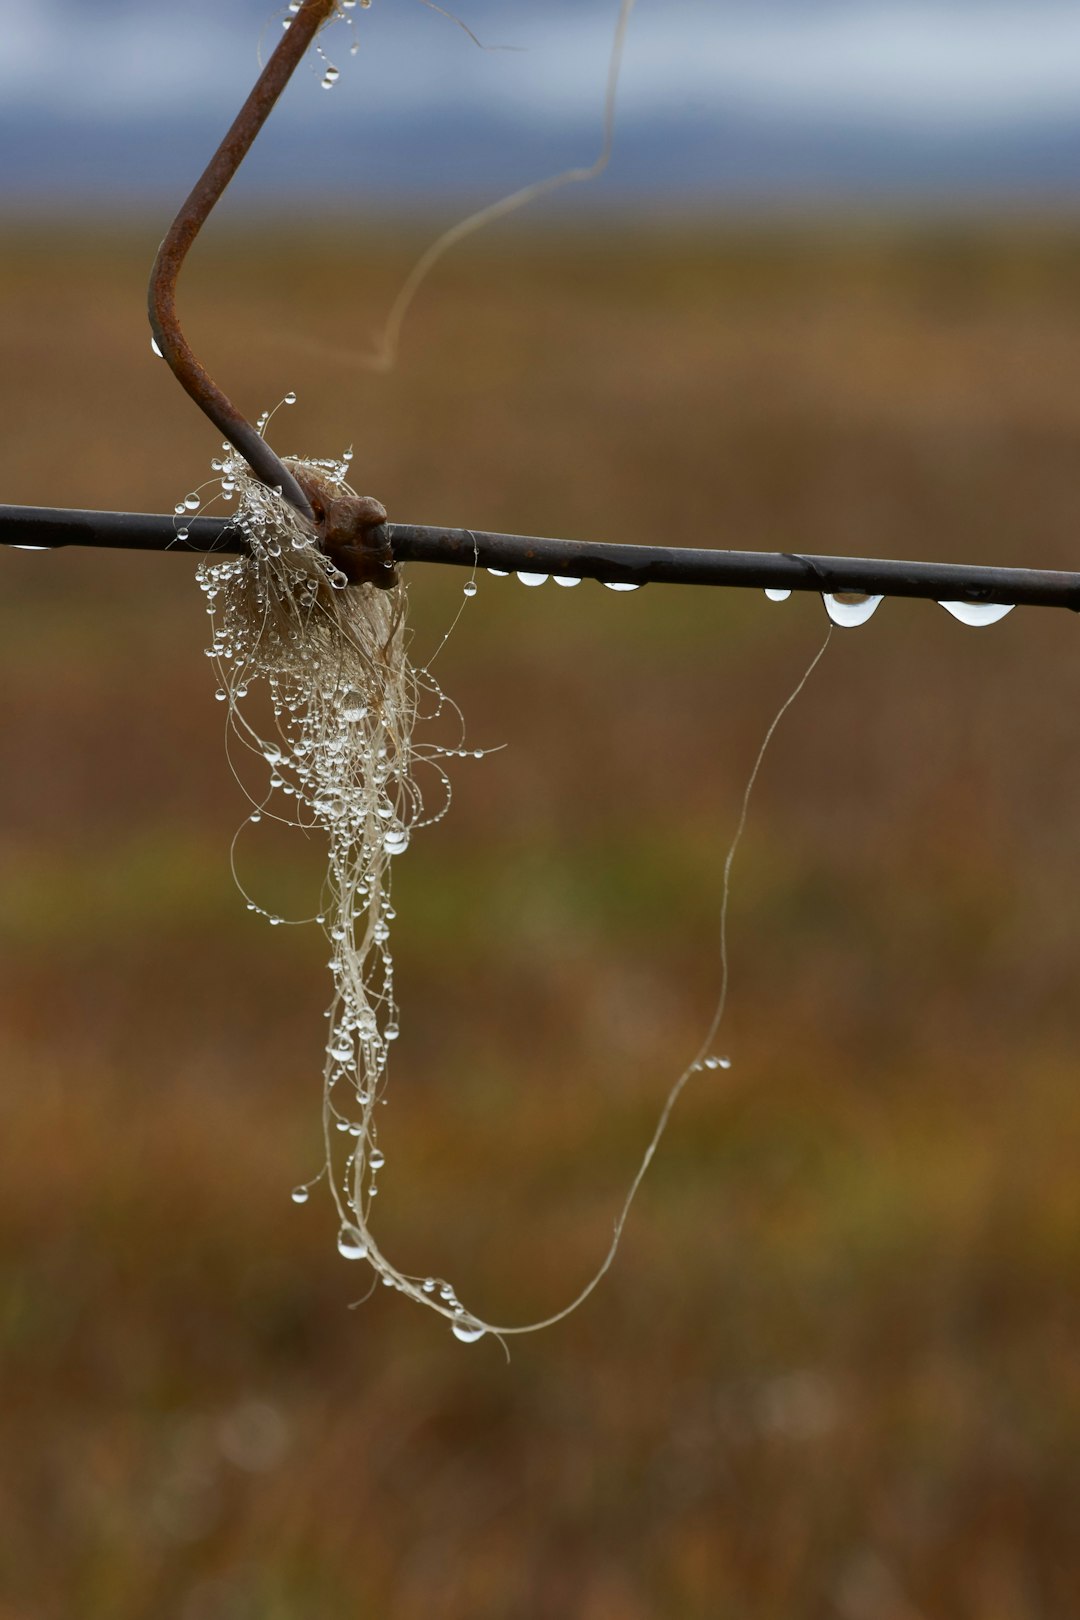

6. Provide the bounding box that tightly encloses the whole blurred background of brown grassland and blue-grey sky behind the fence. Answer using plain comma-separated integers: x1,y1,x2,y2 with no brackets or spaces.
0,0,1080,1620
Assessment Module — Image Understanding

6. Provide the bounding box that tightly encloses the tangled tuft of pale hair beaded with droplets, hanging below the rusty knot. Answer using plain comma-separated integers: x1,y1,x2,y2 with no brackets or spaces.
197,437,486,1343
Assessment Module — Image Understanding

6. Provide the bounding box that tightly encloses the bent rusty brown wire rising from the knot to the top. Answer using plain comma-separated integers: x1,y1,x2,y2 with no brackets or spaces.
149,0,337,517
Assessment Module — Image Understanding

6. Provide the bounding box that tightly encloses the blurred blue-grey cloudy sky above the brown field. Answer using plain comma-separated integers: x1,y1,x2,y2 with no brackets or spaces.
0,0,1080,214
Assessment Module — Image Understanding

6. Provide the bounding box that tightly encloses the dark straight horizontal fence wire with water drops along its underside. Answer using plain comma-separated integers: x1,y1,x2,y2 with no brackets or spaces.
0,505,1080,612
